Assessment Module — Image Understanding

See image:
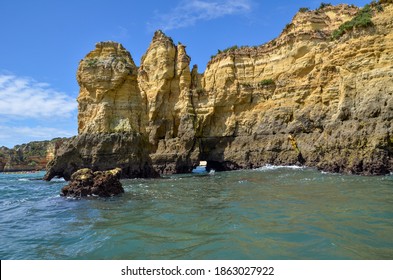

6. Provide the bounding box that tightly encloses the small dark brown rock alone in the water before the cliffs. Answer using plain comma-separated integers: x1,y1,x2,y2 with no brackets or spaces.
61,168,124,197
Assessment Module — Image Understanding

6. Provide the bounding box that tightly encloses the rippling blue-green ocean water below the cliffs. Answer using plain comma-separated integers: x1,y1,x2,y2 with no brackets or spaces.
0,166,393,260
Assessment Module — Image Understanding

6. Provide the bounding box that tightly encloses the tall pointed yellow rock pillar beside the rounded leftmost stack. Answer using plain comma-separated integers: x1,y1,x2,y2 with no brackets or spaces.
138,31,198,173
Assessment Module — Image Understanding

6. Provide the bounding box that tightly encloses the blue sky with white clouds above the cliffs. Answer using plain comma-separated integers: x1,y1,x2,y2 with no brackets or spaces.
0,0,370,148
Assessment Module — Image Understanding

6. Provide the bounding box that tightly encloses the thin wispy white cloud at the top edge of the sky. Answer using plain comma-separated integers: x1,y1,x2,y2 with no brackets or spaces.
151,0,251,30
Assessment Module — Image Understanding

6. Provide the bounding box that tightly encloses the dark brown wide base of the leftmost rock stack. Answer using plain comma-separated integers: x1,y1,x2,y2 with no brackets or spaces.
44,133,158,181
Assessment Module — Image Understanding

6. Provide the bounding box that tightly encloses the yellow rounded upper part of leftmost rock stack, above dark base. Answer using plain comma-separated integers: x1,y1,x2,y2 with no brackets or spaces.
77,42,146,133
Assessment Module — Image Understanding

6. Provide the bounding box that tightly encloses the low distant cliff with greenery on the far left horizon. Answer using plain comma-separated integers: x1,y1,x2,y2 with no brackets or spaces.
0,138,66,172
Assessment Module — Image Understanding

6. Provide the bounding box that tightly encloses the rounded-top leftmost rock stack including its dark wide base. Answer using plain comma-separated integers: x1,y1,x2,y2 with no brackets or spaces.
44,42,158,180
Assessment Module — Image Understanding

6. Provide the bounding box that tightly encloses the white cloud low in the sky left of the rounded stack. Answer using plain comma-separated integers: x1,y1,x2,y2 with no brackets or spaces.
0,74,77,119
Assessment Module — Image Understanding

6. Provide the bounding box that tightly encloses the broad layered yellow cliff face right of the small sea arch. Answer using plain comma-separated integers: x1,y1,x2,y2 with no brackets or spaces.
196,5,393,174
